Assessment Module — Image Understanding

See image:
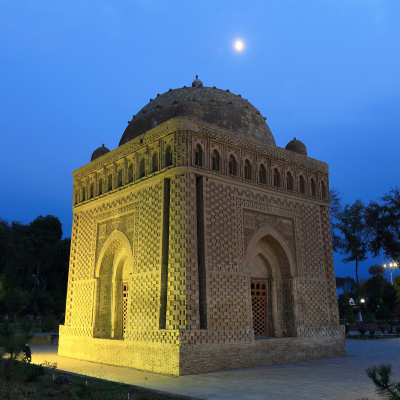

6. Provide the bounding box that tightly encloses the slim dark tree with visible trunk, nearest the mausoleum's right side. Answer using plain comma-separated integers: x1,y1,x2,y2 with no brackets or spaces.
337,200,367,302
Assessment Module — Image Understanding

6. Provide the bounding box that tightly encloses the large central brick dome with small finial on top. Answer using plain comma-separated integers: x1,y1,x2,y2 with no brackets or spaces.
119,77,275,146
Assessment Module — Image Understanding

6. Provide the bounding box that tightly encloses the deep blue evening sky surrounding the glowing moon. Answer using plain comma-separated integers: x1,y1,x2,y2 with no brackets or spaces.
0,0,400,282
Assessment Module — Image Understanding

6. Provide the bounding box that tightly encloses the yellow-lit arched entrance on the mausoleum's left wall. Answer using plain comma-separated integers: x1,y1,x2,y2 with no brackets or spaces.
94,231,133,338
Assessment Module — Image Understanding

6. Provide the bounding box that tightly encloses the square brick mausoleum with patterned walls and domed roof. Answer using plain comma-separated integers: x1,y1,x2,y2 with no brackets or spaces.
59,77,346,375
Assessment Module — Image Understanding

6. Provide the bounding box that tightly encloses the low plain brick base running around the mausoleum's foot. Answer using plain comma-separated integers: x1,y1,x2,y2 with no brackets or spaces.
58,335,347,375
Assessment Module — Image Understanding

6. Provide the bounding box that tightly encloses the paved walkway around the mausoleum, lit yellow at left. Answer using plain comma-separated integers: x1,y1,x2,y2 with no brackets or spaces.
32,338,400,400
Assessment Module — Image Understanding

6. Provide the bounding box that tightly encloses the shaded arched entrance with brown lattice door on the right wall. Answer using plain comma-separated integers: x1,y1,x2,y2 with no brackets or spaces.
245,227,296,337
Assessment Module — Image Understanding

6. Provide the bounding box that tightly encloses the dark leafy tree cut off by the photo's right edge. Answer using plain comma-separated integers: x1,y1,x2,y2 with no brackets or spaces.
365,187,400,262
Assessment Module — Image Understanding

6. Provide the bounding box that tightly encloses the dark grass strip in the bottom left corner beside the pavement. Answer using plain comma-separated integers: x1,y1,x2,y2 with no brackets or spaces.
0,371,195,400
